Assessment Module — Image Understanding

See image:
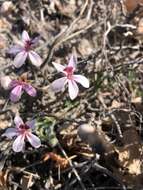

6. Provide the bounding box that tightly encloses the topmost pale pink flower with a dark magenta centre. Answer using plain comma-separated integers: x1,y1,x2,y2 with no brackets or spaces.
8,30,42,68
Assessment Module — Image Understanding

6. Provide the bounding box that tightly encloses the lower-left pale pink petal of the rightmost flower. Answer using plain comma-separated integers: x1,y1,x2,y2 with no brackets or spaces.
51,77,67,92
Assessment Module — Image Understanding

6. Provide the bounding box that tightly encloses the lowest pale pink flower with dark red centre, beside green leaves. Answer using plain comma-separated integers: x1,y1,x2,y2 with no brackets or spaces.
2,116,41,152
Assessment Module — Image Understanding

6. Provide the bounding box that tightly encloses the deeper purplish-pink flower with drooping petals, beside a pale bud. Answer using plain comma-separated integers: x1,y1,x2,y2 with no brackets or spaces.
9,77,37,102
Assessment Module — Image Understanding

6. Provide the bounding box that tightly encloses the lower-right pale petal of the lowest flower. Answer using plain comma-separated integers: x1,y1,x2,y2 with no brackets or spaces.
26,133,41,148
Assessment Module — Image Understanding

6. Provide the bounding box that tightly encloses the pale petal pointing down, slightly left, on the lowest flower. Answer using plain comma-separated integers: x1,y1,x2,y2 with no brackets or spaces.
12,135,25,152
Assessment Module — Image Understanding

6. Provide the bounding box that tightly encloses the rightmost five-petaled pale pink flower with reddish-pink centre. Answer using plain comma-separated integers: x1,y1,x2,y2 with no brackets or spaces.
52,55,89,100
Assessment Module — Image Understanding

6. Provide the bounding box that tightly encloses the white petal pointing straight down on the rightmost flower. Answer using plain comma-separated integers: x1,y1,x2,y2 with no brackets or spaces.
68,80,79,100
